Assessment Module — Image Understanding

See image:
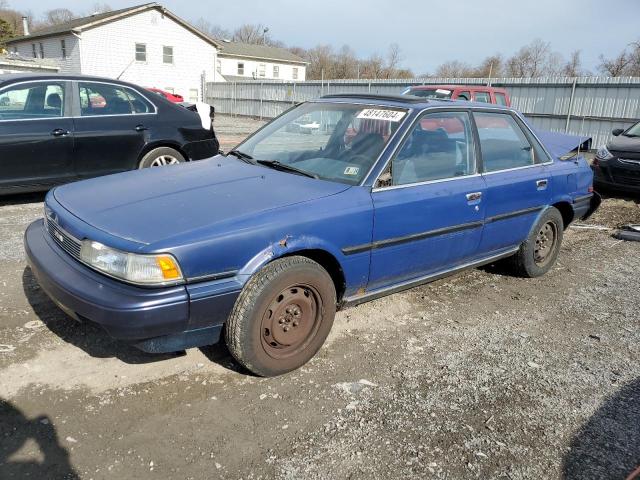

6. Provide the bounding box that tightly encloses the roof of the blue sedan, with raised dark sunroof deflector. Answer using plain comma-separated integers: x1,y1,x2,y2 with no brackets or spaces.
317,93,512,111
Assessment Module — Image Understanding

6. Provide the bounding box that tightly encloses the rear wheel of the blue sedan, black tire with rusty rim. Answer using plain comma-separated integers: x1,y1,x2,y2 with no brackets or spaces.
511,207,564,278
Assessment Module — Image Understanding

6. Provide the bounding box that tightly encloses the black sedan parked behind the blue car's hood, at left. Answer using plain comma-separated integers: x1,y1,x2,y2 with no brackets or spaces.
0,74,219,194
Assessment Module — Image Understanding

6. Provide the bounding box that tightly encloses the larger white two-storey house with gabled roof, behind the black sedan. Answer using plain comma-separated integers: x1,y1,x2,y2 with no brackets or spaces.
7,3,221,102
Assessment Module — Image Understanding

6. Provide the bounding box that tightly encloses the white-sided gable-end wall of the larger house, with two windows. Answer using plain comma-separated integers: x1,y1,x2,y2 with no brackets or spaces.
81,10,218,100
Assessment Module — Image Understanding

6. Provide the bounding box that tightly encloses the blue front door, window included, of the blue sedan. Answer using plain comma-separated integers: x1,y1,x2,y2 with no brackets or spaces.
368,111,485,291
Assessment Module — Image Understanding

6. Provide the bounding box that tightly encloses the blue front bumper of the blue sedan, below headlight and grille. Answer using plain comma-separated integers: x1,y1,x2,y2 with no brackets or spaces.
24,220,238,352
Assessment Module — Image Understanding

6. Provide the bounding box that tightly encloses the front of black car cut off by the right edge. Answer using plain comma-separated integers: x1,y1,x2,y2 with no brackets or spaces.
591,122,640,193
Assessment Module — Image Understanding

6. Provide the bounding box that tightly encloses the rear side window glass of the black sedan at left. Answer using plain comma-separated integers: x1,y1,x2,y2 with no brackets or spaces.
79,82,154,117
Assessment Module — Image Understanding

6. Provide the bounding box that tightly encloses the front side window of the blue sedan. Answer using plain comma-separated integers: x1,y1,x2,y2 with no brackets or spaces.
383,112,476,185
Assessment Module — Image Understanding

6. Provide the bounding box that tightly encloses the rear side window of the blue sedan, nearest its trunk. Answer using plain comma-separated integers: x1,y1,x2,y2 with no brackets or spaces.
473,112,548,172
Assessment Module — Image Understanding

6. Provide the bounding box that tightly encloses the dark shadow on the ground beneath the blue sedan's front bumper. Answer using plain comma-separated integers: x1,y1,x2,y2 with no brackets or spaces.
22,267,184,364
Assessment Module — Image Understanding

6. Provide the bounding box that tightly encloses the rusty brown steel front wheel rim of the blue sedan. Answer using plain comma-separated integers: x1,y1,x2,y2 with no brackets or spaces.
260,285,322,359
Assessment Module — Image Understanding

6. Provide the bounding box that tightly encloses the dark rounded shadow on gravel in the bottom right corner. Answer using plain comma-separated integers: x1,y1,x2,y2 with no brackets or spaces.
563,378,640,480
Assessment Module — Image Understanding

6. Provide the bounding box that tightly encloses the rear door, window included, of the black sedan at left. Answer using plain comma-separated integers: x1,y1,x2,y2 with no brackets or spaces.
74,82,156,177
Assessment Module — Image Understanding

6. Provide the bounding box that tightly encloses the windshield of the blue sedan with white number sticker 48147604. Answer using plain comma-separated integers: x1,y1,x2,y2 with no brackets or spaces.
234,102,407,185
